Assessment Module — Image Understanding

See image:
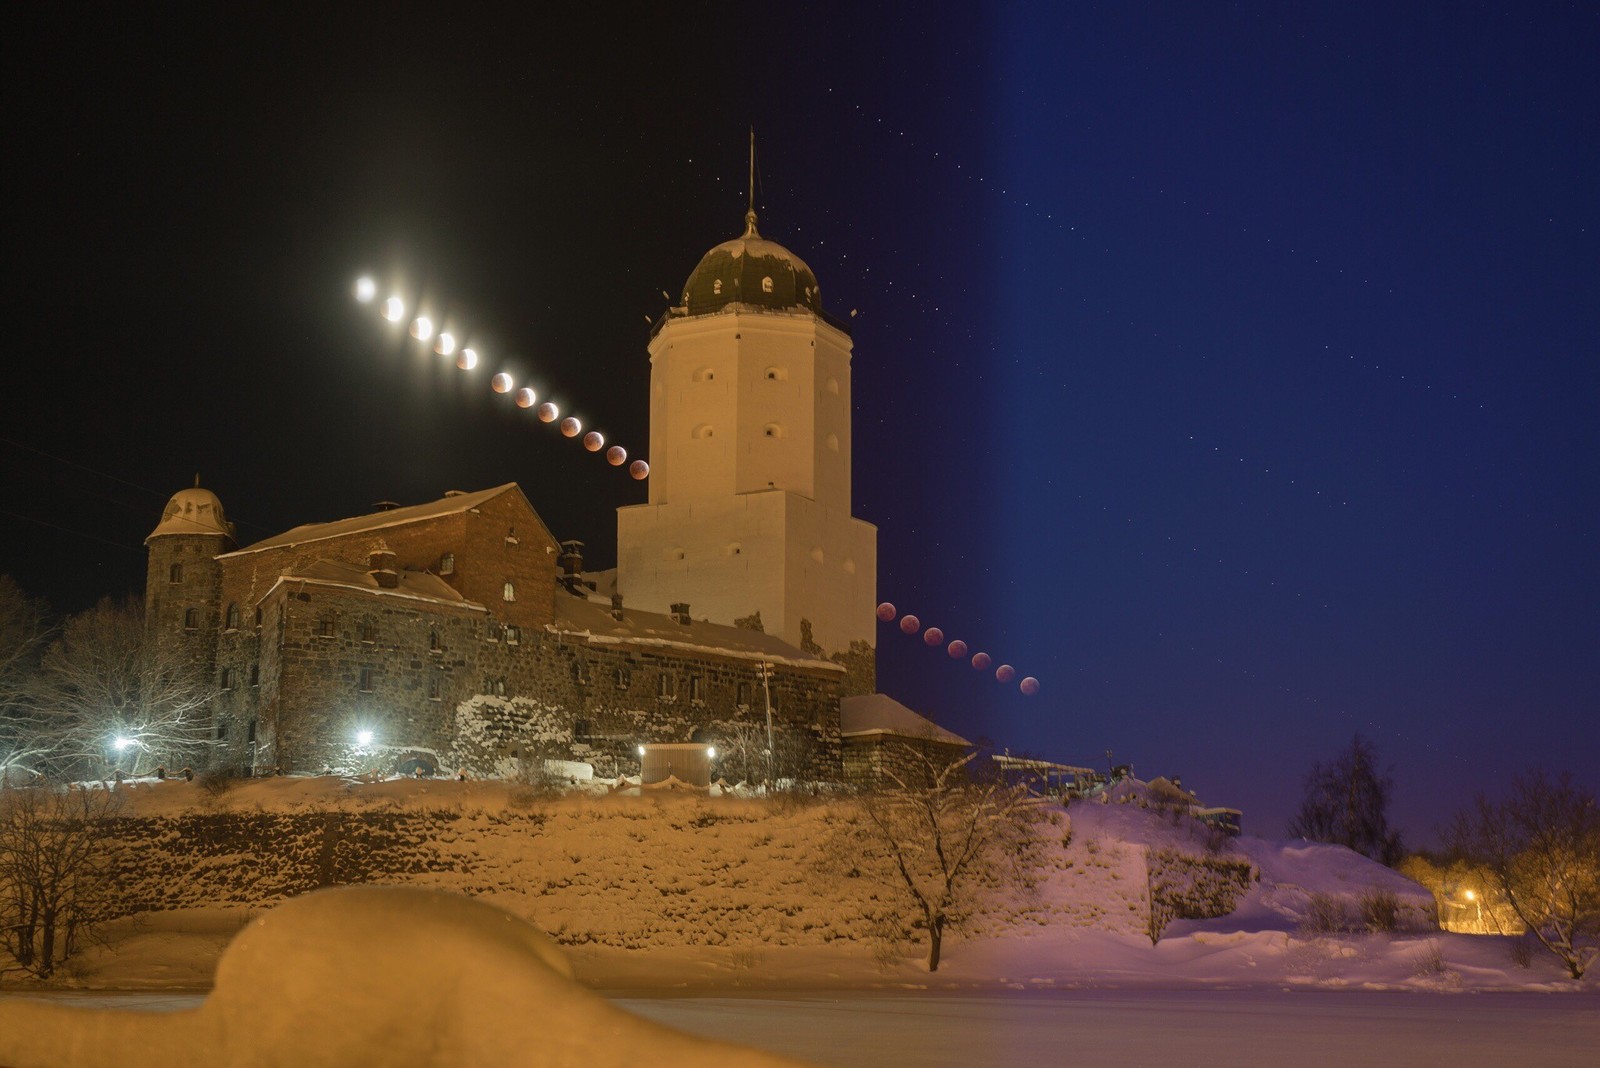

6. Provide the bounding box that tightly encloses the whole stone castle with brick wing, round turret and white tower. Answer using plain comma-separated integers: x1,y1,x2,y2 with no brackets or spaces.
146,204,877,780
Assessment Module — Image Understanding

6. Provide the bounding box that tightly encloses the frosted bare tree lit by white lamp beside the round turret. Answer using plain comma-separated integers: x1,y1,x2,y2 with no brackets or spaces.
27,598,218,775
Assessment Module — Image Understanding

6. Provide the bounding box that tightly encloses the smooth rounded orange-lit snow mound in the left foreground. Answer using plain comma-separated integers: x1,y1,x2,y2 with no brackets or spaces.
0,886,812,1068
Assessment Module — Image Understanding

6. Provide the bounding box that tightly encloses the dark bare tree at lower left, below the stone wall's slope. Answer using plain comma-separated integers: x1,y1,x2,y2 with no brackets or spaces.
0,785,120,978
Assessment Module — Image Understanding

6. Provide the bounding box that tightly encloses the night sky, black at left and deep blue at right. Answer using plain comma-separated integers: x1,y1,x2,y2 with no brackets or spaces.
0,3,1600,844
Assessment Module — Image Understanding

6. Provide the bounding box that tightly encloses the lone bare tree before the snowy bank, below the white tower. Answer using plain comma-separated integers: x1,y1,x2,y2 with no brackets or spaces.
850,745,1040,972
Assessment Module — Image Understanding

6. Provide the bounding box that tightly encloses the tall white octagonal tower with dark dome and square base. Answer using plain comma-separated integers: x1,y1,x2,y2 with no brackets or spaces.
618,202,877,668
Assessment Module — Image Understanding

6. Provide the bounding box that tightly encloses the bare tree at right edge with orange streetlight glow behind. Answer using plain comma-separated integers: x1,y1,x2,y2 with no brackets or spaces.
1448,771,1600,978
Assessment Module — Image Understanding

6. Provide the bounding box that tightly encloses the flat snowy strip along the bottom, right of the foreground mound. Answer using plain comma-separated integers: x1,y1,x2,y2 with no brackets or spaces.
604,990,1600,1068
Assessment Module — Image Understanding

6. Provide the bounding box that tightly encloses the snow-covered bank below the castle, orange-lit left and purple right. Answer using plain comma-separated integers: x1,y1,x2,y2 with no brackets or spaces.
11,779,1600,1004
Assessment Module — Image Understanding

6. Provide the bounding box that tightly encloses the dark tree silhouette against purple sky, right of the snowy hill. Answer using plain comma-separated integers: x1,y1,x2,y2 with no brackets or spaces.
1290,734,1402,865
